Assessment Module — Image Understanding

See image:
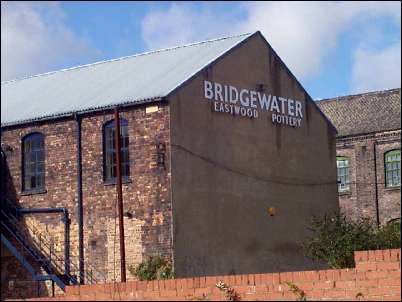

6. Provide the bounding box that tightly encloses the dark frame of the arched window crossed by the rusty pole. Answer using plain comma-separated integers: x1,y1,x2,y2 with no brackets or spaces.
102,118,130,185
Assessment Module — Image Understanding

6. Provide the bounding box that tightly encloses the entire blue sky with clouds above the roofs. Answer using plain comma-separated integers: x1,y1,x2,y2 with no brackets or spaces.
1,1,401,99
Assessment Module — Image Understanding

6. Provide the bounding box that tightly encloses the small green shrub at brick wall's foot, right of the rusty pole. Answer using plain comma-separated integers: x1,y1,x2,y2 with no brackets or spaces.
128,255,174,281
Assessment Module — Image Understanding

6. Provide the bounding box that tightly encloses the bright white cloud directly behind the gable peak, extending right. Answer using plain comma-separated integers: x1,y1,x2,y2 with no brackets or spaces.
232,1,400,78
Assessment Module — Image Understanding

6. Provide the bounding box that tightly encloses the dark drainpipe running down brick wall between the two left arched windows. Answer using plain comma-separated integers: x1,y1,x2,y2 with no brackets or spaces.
74,114,84,284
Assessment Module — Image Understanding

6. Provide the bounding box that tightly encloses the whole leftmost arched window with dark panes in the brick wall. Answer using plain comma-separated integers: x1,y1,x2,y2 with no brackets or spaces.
22,133,45,191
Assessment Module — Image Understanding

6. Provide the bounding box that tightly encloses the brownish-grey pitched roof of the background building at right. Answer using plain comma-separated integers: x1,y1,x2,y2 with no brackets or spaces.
316,88,401,137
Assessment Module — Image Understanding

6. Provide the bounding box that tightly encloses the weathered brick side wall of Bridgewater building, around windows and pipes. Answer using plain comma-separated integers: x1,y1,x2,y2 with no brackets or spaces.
1,104,172,297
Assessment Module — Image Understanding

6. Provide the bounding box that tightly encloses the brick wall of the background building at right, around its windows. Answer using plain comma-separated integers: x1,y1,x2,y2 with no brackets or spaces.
337,130,401,223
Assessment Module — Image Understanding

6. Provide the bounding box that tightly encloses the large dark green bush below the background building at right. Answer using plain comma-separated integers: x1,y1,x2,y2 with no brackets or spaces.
303,214,401,268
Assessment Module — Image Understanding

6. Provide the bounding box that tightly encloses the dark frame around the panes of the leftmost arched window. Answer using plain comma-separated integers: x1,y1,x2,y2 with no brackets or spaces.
21,131,46,194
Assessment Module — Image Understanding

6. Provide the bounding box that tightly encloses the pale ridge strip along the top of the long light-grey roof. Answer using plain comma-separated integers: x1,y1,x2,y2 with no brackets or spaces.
1,32,253,85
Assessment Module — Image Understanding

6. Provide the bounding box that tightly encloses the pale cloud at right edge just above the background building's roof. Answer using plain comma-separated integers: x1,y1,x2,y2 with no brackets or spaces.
351,42,401,93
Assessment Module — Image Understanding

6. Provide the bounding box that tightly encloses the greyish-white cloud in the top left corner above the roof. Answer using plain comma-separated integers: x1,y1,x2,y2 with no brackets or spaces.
1,2,99,81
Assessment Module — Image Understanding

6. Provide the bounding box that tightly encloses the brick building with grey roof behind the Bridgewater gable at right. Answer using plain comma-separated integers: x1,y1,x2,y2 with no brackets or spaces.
317,88,401,224
